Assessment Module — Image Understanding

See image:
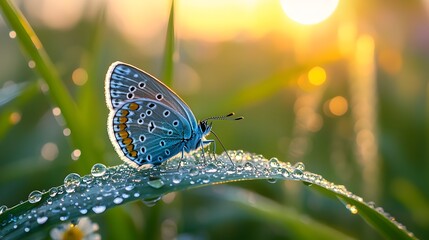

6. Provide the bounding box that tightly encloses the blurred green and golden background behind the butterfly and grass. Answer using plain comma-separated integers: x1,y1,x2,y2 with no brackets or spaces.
0,0,429,239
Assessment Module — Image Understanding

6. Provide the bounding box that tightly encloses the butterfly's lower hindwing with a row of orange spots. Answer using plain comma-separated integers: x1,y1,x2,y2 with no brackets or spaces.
109,99,192,166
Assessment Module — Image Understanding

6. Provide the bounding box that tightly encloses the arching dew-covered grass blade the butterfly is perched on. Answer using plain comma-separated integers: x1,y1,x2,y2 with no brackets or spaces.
0,150,415,239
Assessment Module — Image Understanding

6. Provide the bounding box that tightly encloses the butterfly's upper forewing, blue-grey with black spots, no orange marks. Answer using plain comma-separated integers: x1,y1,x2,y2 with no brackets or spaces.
106,62,198,130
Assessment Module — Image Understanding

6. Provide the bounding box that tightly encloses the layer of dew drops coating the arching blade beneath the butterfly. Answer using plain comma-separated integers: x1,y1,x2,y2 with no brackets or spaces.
0,150,412,235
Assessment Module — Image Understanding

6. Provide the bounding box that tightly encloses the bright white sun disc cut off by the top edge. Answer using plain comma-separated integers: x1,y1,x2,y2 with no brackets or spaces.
281,0,339,25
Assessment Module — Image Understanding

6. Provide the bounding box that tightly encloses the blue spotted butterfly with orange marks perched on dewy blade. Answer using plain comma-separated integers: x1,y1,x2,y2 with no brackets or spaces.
105,62,237,167
